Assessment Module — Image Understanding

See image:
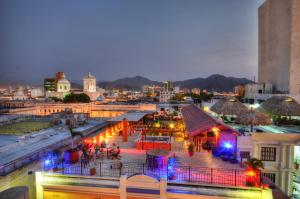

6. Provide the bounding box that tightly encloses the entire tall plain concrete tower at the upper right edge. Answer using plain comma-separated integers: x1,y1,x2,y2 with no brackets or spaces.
258,0,300,100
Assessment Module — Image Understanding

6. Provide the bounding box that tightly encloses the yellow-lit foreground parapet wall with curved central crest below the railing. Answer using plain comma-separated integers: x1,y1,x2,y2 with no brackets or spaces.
36,173,272,199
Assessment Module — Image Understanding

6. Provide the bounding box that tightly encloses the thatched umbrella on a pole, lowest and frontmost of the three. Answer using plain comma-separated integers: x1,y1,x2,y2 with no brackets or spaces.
235,109,272,132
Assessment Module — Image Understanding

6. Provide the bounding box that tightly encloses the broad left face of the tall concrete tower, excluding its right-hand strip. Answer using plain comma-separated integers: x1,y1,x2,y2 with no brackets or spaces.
258,0,291,92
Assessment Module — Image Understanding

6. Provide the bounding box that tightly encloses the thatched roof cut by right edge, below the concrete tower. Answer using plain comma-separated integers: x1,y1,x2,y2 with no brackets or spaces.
258,96,300,116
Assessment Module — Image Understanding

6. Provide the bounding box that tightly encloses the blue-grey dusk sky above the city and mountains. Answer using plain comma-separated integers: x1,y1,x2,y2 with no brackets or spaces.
0,0,263,83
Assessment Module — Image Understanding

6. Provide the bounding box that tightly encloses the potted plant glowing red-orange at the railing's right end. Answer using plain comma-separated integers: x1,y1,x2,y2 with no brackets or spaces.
244,158,264,187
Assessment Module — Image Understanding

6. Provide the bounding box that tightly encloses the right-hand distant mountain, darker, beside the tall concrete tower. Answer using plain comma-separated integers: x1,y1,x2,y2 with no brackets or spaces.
174,74,253,92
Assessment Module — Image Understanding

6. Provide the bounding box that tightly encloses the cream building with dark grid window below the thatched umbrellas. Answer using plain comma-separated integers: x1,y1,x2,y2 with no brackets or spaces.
237,133,300,196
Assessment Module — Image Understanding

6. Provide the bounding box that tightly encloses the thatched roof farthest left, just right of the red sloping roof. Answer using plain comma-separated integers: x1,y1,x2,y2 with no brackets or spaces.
210,97,248,115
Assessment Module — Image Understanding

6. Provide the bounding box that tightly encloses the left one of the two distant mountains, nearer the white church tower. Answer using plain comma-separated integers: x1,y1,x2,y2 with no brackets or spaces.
98,76,162,90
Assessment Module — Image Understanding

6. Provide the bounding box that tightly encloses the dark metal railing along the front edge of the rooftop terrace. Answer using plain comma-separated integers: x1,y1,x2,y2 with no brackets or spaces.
45,162,246,186
